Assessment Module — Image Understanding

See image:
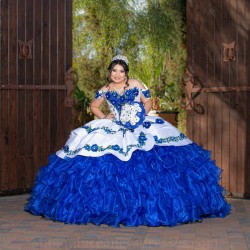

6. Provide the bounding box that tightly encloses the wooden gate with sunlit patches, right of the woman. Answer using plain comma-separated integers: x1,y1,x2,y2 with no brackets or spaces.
186,0,250,197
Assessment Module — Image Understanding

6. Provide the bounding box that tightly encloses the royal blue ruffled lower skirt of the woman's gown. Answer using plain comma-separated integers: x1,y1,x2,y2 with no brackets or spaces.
25,143,231,227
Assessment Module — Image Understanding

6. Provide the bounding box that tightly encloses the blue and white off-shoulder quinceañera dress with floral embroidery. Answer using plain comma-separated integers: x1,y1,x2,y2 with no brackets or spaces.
25,87,231,227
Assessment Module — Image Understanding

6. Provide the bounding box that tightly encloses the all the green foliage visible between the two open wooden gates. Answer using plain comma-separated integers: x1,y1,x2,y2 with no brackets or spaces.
73,0,186,131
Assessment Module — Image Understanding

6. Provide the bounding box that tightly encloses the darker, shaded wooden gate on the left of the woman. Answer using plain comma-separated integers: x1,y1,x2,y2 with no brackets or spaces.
0,0,72,194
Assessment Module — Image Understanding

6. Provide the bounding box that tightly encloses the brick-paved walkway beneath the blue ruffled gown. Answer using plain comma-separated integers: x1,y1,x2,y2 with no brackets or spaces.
0,195,250,250
